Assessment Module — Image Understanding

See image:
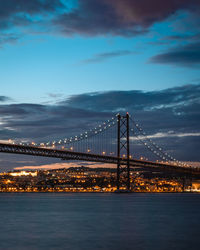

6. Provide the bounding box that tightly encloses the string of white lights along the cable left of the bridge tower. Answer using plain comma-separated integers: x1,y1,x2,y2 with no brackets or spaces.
13,115,117,147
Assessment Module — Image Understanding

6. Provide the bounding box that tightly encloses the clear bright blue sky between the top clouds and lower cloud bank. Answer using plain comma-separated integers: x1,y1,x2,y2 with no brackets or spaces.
0,1,199,103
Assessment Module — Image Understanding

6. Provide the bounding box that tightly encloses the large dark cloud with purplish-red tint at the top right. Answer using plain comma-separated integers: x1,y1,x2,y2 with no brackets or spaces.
55,0,200,36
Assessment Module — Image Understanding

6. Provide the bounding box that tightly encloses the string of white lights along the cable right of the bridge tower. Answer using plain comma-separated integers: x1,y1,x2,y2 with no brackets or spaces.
131,119,190,167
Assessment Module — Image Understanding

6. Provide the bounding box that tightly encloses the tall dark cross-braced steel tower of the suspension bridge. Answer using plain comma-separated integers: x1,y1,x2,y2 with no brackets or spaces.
117,113,130,191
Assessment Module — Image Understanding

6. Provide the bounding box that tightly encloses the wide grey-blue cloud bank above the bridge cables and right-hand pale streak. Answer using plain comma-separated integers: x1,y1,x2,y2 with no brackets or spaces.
0,84,200,140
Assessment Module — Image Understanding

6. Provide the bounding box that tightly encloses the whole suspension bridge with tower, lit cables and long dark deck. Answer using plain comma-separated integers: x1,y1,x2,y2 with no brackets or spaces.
0,113,200,190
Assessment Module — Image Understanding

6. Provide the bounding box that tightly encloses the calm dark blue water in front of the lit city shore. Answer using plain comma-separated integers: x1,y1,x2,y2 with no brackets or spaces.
0,193,200,250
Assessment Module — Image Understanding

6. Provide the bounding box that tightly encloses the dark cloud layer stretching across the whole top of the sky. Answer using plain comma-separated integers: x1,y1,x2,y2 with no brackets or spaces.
0,0,200,43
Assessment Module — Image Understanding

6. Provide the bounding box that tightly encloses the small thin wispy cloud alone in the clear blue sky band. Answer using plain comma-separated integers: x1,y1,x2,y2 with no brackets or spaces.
81,50,133,64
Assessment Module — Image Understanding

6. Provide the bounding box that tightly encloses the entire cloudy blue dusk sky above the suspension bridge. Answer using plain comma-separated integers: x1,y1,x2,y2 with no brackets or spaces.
0,0,200,170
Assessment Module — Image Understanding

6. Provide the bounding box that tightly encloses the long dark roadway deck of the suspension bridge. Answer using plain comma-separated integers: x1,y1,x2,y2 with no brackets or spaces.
0,143,200,177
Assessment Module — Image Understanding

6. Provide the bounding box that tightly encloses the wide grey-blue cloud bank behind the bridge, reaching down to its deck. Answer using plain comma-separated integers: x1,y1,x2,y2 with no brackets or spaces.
0,84,200,168
